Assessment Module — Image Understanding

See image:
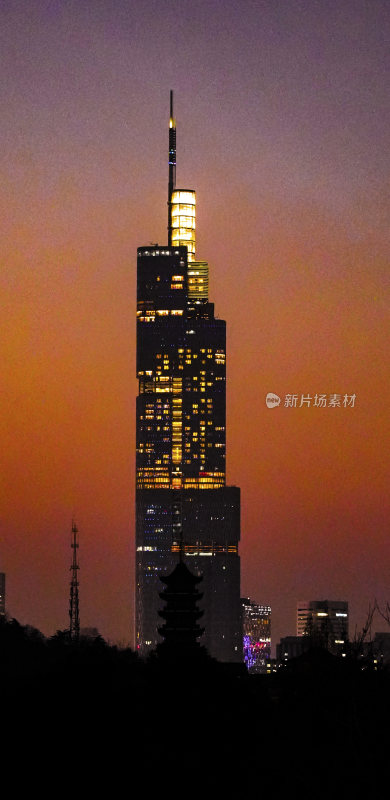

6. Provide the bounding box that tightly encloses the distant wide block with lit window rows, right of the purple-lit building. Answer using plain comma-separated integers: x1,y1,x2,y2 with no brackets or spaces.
297,600,348,653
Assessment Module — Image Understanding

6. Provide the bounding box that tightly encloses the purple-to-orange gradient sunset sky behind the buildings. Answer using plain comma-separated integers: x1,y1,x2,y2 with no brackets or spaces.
0,0,390,642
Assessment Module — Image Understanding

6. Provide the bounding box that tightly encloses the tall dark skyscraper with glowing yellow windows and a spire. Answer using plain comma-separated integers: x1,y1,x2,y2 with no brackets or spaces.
136,92,242,661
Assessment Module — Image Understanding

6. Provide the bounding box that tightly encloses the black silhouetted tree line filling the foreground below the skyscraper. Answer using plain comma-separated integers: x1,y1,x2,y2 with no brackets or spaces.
0,619,390,798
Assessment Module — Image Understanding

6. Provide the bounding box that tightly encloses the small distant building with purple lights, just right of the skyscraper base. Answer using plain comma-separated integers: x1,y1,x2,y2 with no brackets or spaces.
241,597,271,674
